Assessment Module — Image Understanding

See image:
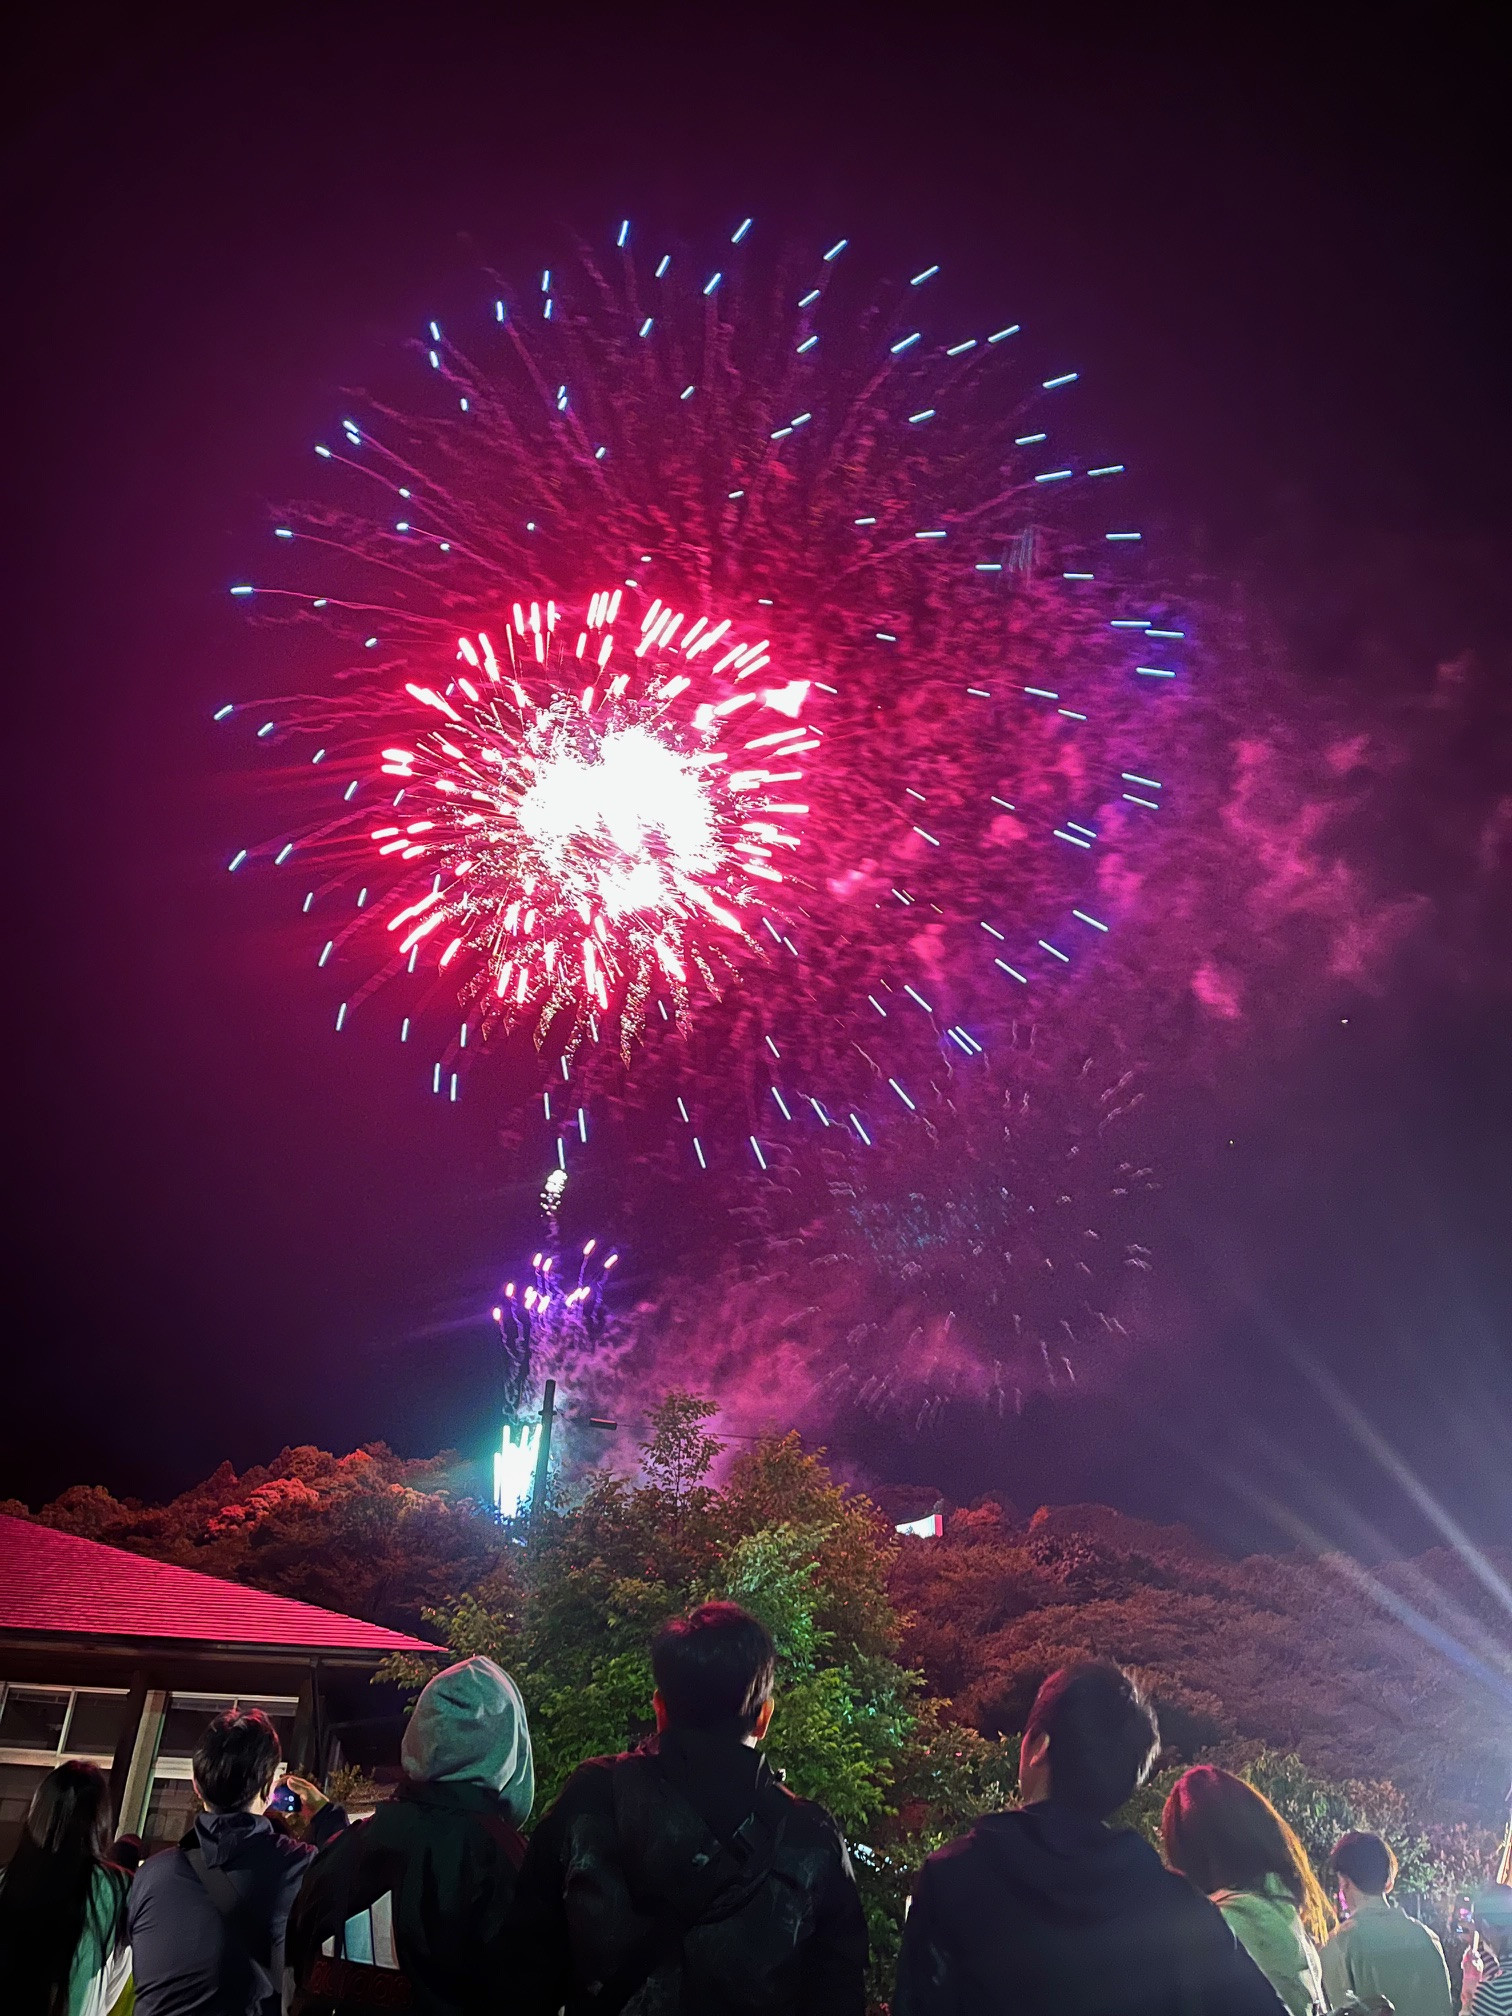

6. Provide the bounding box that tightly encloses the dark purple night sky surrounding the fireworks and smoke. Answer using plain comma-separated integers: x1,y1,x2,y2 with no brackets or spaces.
0,0,1512,1552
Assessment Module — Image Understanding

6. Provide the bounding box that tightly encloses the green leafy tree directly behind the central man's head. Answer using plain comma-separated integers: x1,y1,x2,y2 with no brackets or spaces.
385,1393,917,1829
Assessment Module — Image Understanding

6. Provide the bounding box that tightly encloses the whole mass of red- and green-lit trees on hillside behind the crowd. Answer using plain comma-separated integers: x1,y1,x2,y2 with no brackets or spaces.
26,1419,1512,1998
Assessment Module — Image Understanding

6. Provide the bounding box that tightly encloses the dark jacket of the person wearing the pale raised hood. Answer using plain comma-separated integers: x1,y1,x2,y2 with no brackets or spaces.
288,1782,524,2016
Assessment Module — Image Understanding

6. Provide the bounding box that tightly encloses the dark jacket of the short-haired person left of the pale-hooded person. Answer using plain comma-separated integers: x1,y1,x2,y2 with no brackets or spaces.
127,1806,347,2016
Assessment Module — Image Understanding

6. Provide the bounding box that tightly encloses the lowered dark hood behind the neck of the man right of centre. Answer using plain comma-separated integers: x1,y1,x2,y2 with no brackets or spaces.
972,1800,1167,1925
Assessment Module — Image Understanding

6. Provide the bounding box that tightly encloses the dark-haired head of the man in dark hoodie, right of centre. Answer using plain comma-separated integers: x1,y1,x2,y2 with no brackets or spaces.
1018,1659,1161,1820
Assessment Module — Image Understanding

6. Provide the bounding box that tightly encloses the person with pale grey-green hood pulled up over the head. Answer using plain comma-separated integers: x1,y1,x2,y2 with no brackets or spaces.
288,1659,536,2016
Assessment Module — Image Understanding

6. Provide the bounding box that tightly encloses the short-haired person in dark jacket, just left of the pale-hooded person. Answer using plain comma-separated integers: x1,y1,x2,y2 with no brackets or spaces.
127,1708,347,2016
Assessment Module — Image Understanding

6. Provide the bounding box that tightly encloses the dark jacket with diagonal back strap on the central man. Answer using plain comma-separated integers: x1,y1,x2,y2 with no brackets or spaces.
512,1730,867,2016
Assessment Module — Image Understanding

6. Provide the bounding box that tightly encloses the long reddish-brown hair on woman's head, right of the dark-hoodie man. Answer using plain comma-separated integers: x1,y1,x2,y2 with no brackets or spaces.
1161,1764,1335,1939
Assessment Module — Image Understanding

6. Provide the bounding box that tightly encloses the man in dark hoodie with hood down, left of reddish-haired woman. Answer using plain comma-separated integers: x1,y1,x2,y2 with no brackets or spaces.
893,1659,1284,2016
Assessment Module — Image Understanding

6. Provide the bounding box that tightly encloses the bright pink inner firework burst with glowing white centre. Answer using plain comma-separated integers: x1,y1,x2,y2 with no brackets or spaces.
369,589,818,1052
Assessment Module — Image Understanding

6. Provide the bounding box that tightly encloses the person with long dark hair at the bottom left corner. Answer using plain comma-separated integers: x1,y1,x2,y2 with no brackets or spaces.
0,1762,131,2016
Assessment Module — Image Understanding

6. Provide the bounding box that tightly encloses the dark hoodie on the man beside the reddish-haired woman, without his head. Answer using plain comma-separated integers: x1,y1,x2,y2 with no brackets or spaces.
893,1800,1284,2016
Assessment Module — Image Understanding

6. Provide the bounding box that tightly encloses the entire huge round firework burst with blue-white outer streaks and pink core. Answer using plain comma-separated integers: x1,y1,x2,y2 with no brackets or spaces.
221,224,1185,1171
